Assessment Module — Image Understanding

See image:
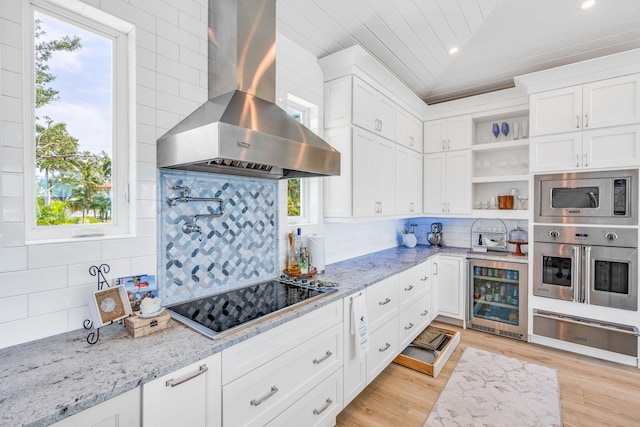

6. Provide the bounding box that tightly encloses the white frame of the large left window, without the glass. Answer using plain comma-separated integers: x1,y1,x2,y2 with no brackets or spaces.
23,0,136,244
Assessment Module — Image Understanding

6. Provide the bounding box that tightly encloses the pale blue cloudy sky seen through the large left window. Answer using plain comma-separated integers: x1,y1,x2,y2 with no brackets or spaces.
35,12,113,155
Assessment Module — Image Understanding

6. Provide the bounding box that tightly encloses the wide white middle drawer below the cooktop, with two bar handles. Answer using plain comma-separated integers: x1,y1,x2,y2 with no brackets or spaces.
222,324,342,426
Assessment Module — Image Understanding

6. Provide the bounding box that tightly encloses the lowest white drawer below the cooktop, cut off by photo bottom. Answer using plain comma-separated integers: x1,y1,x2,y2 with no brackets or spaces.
267,369,342,427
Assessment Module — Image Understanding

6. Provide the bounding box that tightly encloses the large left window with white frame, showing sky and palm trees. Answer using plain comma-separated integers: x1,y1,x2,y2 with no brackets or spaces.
25,0,133,242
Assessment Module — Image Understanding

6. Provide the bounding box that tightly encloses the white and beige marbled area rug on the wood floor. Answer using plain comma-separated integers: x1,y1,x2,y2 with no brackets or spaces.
424,347,562,427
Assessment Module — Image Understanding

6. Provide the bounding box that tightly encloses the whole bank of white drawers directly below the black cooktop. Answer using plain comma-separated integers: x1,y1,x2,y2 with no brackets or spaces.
222,301,343,426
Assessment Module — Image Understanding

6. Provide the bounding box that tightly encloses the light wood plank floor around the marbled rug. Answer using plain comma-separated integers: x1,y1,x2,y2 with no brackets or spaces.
337,325,640,427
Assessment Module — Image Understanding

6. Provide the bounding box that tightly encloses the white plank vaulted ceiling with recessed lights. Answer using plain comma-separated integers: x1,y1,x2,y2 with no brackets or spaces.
277,0,640,104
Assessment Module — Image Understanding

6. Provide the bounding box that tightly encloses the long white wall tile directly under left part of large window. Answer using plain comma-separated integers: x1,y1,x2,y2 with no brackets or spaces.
29,240,102,269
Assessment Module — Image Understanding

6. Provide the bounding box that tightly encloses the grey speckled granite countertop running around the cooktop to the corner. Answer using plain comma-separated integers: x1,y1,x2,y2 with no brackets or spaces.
0,245,526,427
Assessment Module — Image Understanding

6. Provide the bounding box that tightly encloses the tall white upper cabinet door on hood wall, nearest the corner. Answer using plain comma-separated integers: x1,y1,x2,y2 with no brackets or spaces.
395,146,422,214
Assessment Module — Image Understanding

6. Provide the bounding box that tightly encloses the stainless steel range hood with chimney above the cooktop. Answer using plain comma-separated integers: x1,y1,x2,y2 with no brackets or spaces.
158,0,340,178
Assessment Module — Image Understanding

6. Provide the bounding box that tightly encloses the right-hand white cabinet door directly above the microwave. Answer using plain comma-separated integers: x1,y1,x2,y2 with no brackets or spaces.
582,125,640,168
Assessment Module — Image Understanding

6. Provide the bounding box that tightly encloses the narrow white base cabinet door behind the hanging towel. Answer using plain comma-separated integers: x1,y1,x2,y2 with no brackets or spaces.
343,289,371,406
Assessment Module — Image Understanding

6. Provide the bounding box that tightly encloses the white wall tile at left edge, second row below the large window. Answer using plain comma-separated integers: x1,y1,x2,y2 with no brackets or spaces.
0,266,67,298
